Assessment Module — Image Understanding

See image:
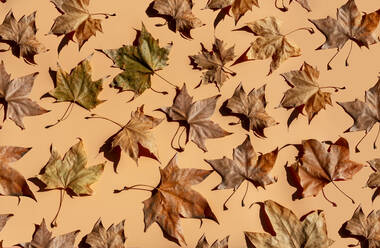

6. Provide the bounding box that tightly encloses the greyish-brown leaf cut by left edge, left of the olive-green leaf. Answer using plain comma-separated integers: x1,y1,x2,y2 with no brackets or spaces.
0,61,49,129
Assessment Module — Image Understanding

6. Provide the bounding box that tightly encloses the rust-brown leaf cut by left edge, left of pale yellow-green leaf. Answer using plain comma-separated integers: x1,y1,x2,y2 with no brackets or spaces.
0,146,36,201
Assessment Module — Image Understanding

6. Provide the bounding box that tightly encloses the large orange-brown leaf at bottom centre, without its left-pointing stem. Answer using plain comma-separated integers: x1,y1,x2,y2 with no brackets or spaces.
144,154,218,245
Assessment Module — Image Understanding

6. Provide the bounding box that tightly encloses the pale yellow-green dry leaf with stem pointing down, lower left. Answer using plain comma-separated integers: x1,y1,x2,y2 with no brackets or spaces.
37,139,105,227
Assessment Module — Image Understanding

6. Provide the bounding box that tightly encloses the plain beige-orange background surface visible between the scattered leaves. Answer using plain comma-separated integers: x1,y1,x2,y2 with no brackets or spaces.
0,0,380,248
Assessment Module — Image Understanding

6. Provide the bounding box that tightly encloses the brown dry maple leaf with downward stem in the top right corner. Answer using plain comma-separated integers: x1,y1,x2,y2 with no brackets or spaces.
309,0,380,70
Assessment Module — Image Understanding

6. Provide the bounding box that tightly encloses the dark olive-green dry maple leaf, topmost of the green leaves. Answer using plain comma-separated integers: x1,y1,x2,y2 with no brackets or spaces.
100,24,171,100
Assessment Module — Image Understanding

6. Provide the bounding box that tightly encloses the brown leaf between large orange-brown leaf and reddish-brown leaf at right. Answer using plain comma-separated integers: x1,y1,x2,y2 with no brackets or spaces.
205,135,278,210
